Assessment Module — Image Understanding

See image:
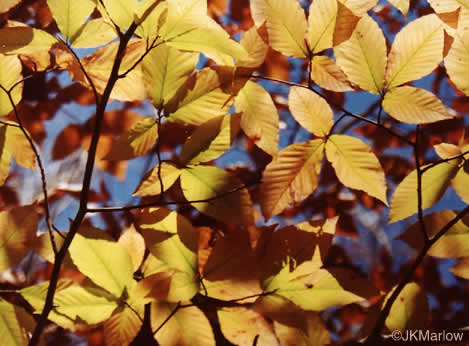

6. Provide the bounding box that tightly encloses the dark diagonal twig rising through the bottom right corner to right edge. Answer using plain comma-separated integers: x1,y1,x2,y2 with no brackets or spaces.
365,206,469,345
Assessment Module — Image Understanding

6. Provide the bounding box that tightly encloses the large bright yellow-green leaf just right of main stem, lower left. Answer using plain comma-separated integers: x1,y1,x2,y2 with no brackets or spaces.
69,233,134,297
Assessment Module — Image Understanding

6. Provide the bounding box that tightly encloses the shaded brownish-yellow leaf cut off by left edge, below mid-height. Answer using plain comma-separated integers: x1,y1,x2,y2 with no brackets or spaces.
0,205,39,271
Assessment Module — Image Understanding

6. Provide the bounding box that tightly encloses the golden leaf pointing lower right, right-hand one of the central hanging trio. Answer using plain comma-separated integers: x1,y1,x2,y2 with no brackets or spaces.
326,135,388,205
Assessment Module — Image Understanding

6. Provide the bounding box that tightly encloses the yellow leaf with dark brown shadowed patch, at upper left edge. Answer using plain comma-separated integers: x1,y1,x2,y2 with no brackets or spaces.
0,24,58,71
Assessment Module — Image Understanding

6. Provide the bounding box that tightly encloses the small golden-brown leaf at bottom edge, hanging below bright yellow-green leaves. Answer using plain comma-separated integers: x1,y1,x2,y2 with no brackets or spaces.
103,304,144,346
